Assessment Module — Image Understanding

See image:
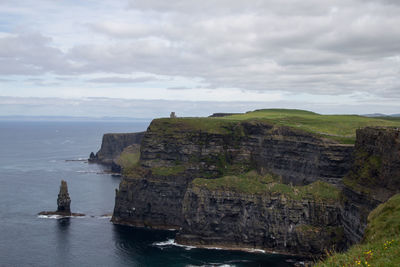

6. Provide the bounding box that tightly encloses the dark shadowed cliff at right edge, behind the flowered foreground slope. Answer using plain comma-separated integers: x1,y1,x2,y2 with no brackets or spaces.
342,127,400,244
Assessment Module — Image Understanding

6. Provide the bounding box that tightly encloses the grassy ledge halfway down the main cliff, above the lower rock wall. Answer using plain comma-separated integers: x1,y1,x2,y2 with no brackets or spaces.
193,171,339,202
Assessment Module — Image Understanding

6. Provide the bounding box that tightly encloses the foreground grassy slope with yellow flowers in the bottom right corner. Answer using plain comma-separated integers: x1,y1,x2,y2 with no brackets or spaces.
316,194,400,267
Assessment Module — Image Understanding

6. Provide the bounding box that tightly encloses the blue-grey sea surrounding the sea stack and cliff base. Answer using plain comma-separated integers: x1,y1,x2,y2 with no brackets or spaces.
0,121,300,266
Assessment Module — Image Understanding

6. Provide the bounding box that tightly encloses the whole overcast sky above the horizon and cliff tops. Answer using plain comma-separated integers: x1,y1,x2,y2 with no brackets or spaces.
0,0,400,118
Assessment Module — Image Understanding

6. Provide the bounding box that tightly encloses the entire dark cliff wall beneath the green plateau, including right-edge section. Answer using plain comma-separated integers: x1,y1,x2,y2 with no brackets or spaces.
106,115,400,256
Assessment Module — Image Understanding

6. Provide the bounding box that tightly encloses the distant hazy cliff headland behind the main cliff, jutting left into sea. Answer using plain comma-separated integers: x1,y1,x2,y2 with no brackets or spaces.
89,132,145,167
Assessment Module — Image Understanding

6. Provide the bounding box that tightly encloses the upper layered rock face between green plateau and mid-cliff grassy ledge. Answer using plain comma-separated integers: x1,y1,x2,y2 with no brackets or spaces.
140,120,353,185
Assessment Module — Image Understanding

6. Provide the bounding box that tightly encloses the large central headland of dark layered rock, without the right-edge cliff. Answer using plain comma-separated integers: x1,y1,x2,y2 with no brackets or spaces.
112,119,353,255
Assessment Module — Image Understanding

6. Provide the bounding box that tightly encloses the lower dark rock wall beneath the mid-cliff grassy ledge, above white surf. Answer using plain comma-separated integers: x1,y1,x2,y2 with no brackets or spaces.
177,186,345,256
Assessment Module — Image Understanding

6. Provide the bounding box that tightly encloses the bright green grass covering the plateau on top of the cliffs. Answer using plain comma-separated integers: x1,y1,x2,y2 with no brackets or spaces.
152,109,400,144
